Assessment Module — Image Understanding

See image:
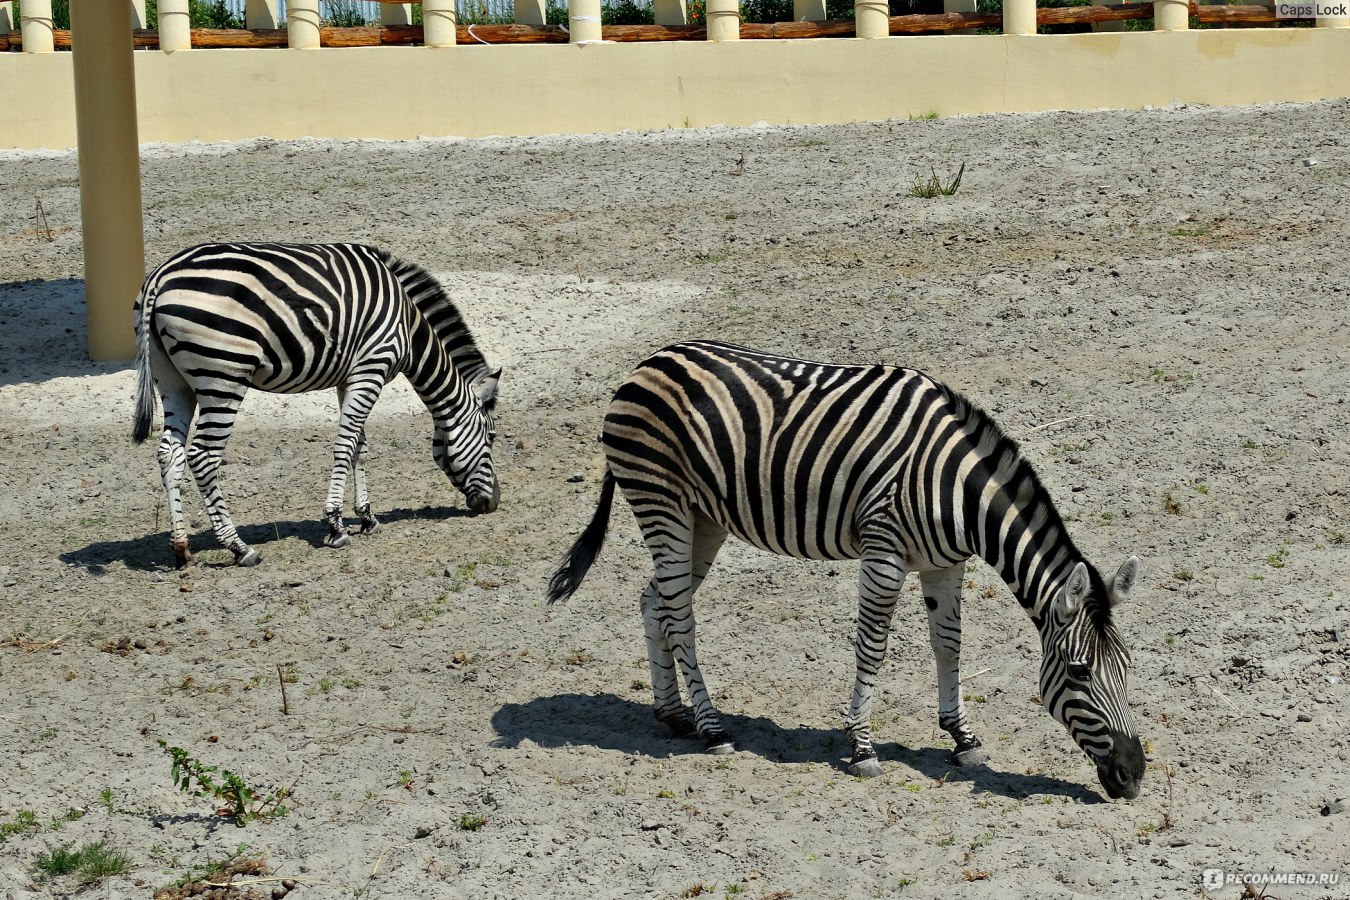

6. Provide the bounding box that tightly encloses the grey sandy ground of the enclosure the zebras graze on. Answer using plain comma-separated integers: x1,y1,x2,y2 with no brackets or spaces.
0,101,1350,900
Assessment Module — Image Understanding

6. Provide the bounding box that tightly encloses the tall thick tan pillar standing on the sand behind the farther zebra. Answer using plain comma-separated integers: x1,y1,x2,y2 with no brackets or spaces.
71,0,145,360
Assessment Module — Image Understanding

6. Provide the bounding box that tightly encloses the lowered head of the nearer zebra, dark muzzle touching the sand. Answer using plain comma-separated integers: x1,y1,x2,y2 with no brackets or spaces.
1041,556,1145,800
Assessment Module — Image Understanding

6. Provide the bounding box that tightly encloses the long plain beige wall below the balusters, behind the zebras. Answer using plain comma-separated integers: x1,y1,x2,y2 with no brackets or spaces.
0,28,1350,148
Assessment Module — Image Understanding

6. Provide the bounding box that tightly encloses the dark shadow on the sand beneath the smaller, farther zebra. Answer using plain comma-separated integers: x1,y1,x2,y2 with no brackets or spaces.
59,506,474,575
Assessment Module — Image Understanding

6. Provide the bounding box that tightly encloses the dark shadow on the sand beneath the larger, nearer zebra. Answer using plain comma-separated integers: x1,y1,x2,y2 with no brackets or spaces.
493,694,1104,803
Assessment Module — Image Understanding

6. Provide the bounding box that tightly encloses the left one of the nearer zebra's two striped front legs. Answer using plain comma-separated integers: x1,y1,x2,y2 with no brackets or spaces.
844,549,906,779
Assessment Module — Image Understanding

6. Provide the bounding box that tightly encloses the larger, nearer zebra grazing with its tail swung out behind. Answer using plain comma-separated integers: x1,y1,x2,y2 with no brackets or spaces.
548,341,1145,797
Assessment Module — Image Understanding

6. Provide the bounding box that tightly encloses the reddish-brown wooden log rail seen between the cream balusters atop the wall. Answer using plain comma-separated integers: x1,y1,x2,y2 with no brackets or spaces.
0,3,1277,50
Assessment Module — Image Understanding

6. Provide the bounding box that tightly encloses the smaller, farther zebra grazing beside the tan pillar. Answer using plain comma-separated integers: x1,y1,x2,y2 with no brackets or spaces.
132,243,501,567
